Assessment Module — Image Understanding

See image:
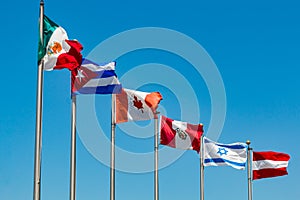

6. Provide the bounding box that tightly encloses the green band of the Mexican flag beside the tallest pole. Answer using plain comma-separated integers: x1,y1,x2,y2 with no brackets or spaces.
38,15,58,62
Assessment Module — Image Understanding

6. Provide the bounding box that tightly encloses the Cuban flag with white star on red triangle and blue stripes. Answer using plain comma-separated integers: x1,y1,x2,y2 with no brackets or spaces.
72,59,122,95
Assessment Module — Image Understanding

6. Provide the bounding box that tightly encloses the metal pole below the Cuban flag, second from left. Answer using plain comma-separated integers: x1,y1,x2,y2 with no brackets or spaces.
70,95,76,200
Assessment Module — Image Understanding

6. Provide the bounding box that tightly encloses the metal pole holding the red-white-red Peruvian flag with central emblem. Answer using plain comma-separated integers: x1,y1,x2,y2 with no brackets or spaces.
154,112,159,200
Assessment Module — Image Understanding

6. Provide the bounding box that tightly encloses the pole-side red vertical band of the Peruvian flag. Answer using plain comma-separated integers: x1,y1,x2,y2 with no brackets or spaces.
160,116,176,148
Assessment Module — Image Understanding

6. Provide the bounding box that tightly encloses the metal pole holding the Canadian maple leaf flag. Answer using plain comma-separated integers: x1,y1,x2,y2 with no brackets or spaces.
110,94,116,200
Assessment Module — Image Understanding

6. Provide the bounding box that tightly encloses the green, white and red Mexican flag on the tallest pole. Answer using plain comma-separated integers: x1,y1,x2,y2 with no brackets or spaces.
38,15,82,71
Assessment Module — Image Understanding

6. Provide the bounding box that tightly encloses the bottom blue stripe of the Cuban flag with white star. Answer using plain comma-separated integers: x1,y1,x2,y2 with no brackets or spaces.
73,85,122,95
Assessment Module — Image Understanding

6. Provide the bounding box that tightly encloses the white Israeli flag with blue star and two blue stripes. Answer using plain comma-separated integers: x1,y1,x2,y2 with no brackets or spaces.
203,137,247,170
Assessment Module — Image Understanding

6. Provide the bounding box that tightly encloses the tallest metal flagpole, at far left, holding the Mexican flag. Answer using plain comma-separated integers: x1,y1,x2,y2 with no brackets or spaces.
33,0,44,200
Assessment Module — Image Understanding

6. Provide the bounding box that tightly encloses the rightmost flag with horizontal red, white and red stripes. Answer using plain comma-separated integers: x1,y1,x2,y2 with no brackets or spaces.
252,151,290,180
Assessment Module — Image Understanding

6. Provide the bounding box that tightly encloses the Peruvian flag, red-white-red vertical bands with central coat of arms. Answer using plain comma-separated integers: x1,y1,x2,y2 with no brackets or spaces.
160,116,203,153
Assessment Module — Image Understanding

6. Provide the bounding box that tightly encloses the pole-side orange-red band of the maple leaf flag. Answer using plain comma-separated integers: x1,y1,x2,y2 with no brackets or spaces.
115,89,128,123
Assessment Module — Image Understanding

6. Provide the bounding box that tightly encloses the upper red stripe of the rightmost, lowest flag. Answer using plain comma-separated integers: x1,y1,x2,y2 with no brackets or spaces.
253,151,290,161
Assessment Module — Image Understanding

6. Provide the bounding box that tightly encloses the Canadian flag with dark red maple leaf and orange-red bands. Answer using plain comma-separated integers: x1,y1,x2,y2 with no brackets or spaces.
115,89,162,124
